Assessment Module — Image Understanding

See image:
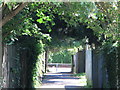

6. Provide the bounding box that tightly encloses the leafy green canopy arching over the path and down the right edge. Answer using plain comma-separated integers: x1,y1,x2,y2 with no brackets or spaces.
3,2,120,87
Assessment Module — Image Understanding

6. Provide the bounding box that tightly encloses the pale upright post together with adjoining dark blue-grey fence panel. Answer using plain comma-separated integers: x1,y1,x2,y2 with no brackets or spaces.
85,46,108,88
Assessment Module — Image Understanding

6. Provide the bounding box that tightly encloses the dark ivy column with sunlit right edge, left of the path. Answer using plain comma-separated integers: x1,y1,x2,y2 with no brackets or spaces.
16,36,44,88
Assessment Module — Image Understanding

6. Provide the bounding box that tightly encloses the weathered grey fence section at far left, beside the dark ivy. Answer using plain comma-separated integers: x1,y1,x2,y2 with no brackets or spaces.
2,45,20,88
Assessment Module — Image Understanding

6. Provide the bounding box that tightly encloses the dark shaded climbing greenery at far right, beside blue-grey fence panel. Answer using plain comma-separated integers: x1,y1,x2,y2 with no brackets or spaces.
104,43,120,88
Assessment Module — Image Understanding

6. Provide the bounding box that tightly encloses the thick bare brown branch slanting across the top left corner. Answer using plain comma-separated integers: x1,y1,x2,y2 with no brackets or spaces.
0,2,28,27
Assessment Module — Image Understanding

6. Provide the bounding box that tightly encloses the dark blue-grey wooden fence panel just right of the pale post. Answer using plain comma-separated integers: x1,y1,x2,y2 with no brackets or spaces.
92,50,108,88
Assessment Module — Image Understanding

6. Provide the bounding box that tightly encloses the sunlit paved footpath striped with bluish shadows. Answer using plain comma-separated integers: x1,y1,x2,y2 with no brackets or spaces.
40,72,85,90
